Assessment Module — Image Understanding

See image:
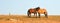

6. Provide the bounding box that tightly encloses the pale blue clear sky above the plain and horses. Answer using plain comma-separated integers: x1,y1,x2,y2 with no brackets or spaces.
0,0,60,14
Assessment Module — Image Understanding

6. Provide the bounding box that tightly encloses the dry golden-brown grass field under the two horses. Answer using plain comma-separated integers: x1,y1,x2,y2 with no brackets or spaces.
0,15,60,23
